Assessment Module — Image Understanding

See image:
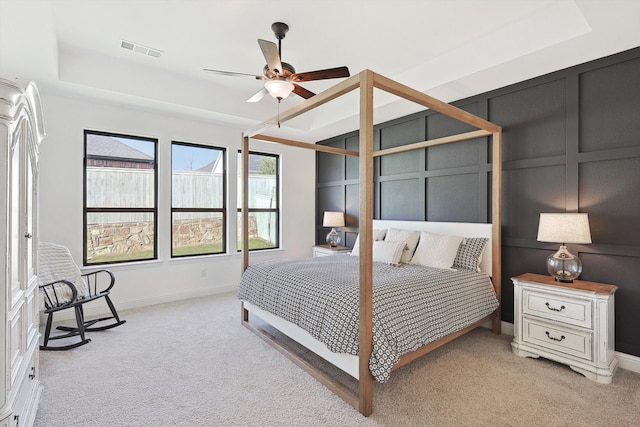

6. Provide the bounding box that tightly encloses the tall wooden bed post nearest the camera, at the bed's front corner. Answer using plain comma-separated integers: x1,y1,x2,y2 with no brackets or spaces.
358,70,373,417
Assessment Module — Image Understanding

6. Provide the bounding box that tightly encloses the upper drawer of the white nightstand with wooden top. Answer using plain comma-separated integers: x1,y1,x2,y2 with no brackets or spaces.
522,289,593,328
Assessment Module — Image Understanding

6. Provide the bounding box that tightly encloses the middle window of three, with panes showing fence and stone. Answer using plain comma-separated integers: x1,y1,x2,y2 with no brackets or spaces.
171,142,227,257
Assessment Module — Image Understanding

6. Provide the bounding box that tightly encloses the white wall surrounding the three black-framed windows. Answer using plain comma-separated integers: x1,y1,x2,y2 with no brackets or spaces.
39,88,315,315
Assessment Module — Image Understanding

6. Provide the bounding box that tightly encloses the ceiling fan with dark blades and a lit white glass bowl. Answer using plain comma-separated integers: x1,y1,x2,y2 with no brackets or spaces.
204,22,350,102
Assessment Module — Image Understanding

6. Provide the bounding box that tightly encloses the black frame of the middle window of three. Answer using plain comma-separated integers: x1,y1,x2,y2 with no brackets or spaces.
169,140,229,259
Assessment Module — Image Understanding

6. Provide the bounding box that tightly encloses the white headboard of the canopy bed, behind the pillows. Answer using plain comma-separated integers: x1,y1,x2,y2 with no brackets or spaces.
373,219,493,276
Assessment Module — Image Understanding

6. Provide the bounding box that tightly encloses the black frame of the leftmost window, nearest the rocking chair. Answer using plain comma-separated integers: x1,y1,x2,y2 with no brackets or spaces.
82,129,158,267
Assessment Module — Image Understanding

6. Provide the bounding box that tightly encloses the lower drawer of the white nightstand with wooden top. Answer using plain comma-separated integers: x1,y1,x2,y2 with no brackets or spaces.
522,317,593,360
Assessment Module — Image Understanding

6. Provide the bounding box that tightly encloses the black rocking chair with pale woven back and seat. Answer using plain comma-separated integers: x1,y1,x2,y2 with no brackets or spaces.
38,242,126,350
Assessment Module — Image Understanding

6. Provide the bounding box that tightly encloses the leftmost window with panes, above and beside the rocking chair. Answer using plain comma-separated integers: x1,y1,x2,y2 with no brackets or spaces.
84,130,158,265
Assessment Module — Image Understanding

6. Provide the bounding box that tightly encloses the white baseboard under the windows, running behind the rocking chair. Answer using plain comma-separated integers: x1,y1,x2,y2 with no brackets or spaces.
40,286,238,325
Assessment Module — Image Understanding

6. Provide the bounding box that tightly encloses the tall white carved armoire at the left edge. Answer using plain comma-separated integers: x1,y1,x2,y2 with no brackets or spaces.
0,78,44,427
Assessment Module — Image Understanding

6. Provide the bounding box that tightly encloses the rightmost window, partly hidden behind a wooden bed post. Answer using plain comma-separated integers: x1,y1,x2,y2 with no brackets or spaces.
238,152,280,251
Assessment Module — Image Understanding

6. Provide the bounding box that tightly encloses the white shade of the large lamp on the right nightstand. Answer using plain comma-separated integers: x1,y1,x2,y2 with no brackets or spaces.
538,213,591,243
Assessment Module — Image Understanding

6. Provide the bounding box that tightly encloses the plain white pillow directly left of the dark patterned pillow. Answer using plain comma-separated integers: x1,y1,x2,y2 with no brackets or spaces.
411,231,464,268
